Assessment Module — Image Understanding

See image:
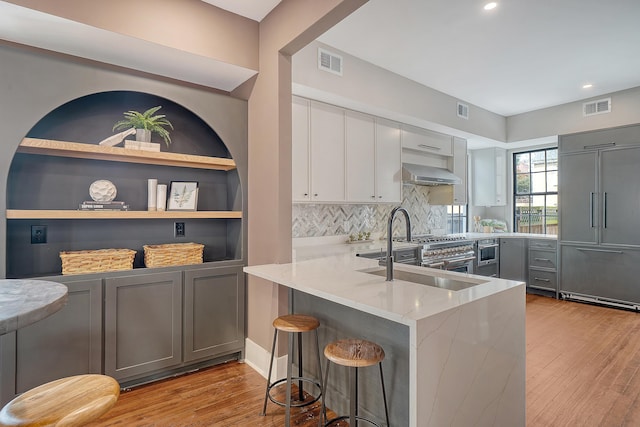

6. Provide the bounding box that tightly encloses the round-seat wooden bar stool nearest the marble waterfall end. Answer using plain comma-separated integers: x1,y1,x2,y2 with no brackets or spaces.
320,339,389,427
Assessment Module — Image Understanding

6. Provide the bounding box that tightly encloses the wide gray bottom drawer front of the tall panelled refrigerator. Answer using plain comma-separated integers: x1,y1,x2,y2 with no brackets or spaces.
560,245,640,304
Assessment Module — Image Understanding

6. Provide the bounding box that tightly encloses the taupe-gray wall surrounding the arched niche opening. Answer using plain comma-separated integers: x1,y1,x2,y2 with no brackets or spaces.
0,44,248,277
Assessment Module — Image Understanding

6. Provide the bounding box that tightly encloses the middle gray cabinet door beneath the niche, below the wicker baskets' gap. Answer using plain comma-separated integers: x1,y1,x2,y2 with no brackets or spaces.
104,271,182,380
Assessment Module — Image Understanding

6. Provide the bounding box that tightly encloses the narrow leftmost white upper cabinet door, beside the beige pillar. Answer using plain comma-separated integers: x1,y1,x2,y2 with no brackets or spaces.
291,96,311,202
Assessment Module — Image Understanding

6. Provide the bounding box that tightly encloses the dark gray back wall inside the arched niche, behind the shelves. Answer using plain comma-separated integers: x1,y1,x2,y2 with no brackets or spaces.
6,91,242,278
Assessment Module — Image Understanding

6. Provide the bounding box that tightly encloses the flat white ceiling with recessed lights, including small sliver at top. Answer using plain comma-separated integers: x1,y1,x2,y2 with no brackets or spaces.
207,0,640,116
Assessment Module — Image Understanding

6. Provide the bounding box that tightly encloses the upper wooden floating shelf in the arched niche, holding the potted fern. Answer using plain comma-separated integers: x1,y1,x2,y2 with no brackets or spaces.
17,138,236,171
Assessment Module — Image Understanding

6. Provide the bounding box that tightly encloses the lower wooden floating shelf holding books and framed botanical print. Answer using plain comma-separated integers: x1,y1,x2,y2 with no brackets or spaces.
7,209,242,219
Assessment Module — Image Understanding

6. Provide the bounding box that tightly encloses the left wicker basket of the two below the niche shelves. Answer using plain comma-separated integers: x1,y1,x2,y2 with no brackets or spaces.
60,249,136,274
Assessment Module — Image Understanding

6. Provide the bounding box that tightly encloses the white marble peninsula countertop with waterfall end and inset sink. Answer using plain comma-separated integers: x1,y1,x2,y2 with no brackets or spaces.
244,242,525,427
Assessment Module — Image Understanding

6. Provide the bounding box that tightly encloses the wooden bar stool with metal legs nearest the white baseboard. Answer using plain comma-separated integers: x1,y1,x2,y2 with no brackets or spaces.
260,314,322,427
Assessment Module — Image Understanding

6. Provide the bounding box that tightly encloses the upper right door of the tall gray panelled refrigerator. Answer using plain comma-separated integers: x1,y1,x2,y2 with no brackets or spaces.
600,147,640,246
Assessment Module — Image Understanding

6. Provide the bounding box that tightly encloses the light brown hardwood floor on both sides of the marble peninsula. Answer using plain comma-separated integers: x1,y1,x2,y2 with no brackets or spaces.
91,295,640,427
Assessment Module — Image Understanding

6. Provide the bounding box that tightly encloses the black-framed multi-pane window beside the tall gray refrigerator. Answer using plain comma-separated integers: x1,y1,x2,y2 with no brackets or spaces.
513,148,558,234
